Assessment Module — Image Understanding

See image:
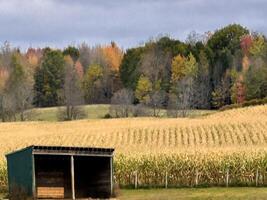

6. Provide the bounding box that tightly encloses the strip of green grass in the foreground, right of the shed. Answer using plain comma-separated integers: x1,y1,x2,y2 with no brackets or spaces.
121,187,267,200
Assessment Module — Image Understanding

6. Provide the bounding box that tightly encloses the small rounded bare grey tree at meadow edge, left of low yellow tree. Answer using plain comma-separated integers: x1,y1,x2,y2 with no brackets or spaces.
110,88,134,117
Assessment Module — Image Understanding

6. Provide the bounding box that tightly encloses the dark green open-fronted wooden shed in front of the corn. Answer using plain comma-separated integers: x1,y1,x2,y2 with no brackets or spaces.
6,146,114,199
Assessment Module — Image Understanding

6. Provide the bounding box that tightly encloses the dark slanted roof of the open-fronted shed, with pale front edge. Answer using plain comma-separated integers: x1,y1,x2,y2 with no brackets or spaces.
6,145,114,157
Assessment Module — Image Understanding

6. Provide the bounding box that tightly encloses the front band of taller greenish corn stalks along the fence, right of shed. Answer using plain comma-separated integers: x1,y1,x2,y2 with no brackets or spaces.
115,152,267,187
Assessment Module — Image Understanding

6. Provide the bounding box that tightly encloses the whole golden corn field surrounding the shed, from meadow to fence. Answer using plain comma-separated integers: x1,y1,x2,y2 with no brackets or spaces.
0,105,267,187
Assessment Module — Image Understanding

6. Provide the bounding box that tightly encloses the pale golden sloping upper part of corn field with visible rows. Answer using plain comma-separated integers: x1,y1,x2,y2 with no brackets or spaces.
0,105,267,159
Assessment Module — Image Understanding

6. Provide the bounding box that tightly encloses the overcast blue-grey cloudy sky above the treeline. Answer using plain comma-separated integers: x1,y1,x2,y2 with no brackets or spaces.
0,0,267,49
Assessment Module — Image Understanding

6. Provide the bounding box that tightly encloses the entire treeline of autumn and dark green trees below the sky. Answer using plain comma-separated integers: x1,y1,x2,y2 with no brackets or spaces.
0,24,267,121
